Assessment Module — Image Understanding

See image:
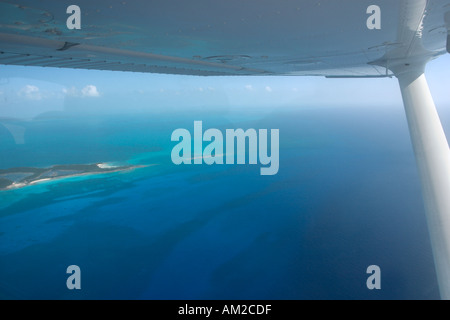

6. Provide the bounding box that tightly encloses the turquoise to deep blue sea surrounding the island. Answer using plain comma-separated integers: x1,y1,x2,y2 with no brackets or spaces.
0,107,438,299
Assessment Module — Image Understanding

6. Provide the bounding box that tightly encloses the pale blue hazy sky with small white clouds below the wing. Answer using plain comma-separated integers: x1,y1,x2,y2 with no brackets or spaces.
0,55,450,122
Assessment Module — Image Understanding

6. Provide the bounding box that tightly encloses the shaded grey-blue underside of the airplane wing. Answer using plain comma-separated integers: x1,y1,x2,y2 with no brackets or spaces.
0,0,450,77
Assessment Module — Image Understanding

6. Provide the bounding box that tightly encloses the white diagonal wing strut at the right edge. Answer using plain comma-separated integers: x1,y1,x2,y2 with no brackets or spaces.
395,63,450,300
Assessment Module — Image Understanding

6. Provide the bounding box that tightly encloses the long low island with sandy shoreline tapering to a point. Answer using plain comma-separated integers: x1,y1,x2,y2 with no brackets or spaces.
0,163,146,191
